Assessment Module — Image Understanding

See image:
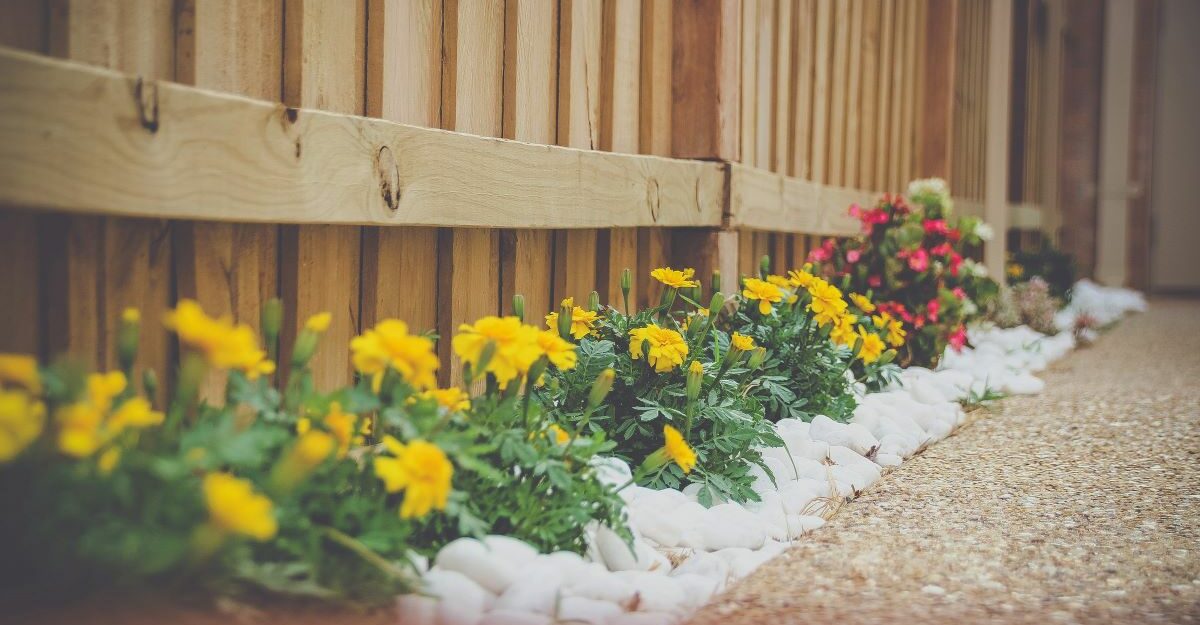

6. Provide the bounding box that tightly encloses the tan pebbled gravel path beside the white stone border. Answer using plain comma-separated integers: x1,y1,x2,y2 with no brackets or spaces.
694,300,1200,625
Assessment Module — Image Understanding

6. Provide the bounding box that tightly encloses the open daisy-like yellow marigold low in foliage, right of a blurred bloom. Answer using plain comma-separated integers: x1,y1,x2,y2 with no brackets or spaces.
374,437,454,518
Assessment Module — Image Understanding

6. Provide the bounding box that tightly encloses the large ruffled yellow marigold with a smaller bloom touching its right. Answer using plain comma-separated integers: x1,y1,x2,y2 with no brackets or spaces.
451,315,542,389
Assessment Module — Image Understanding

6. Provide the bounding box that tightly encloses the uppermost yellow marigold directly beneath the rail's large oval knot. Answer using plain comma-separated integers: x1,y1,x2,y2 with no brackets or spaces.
350,319,438,389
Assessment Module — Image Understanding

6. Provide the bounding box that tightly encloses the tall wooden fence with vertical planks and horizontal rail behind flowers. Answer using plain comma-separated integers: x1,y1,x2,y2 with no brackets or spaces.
0,0,1000,395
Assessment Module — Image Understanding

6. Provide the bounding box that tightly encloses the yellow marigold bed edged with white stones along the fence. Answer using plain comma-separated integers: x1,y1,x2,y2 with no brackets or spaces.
0,181,1144,624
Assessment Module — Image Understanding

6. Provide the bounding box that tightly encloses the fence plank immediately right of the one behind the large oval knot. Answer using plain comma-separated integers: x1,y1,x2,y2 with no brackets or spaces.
438,0,504,384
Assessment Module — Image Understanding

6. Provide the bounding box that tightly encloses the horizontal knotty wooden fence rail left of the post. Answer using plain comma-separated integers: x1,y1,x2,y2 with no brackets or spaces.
0,50,724,228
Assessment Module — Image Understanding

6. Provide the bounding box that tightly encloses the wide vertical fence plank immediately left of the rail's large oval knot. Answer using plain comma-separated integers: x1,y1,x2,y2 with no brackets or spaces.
280,0,366,389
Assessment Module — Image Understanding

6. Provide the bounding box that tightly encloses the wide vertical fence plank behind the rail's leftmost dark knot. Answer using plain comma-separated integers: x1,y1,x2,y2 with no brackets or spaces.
41,0,174,395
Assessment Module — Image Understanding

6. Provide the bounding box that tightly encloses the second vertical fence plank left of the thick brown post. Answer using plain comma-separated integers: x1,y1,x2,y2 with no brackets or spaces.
596,0,642,304
